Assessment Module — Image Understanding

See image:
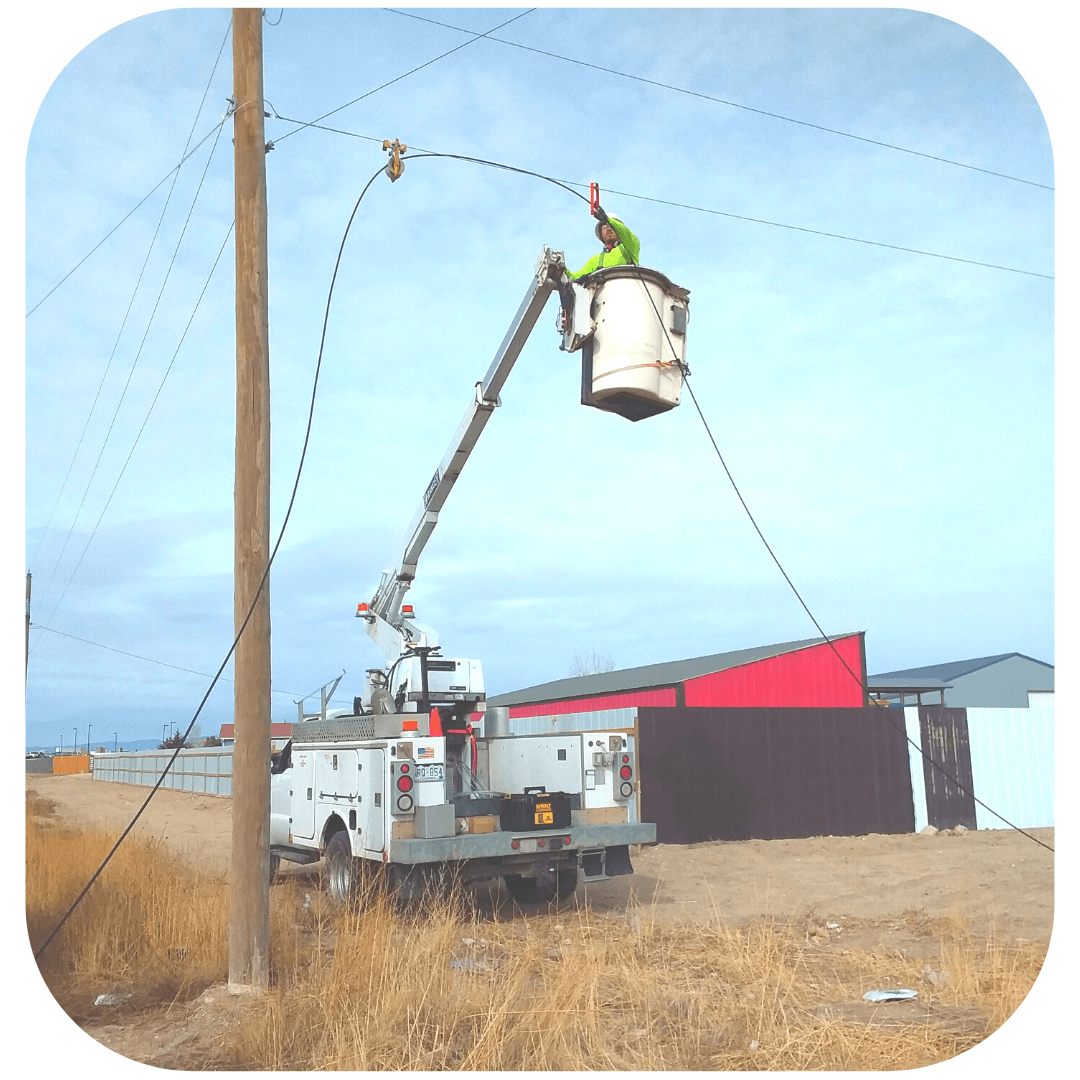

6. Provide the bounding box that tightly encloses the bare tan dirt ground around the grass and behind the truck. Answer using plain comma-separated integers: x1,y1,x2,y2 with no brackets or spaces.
26,774,1054,1067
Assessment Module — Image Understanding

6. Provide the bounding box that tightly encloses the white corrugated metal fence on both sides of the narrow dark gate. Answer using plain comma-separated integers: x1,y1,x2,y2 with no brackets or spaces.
904,705,1054,832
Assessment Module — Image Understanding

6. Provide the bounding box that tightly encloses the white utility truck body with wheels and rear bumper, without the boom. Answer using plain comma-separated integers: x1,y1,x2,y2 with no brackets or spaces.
270,713,656,900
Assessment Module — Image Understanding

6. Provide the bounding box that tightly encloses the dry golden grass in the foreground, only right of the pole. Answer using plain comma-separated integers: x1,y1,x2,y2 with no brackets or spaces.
229,885,1042,1071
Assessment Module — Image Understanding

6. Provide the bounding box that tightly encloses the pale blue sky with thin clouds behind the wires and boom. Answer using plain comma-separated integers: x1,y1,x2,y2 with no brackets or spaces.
15,8,1059,745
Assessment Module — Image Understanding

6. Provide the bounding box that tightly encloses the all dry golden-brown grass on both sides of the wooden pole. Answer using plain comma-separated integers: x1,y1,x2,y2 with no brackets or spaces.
27,805,1044,1071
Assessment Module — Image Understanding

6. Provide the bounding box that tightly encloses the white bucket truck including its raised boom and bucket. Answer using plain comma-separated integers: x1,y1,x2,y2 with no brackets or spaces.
270,247,689,903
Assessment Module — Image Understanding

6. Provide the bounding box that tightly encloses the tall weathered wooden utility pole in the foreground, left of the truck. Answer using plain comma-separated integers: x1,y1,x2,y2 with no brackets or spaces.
229,8,270,993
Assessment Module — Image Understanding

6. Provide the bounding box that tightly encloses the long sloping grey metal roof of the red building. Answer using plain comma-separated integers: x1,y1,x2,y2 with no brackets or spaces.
487,631,858,705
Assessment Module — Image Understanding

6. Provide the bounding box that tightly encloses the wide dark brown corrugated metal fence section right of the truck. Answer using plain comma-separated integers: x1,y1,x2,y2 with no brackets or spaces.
637,707,914,843
